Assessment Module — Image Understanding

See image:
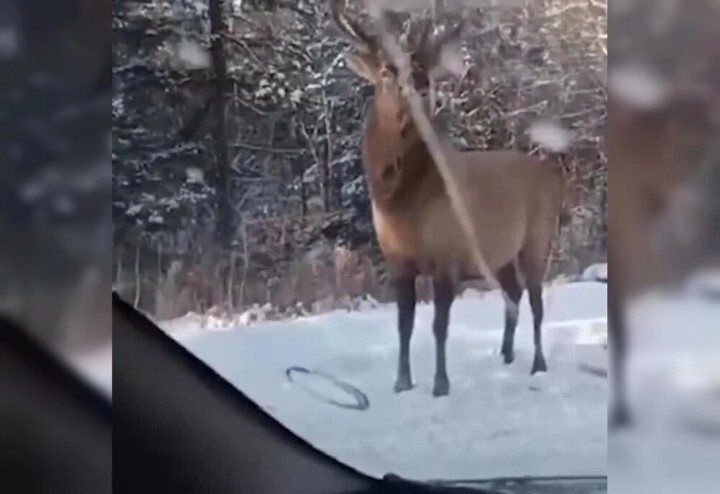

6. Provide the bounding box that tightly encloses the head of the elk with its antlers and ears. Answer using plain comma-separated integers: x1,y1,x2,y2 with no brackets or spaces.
330,0,462,132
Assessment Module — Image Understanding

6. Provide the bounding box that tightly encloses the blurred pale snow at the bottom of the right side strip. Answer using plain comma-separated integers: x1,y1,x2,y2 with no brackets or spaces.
608,288,720,494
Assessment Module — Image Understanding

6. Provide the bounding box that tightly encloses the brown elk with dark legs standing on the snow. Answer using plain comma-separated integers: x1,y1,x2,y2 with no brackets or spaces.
331,0,564,396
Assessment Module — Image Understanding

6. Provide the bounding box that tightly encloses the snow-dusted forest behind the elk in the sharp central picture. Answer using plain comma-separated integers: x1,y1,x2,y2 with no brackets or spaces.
112,0,607,319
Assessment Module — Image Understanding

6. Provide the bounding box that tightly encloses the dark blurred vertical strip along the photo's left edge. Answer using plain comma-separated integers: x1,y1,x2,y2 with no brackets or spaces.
0,0,112,494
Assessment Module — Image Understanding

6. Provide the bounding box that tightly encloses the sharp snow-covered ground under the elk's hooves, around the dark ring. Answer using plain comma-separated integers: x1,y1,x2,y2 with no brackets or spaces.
167,282,608,479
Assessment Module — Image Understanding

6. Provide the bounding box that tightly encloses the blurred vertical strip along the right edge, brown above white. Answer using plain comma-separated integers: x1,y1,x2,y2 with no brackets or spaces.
608,0,720,493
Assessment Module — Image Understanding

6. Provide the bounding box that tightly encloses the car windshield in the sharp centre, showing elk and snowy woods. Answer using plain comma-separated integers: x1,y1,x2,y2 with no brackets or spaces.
112,0,608,480
